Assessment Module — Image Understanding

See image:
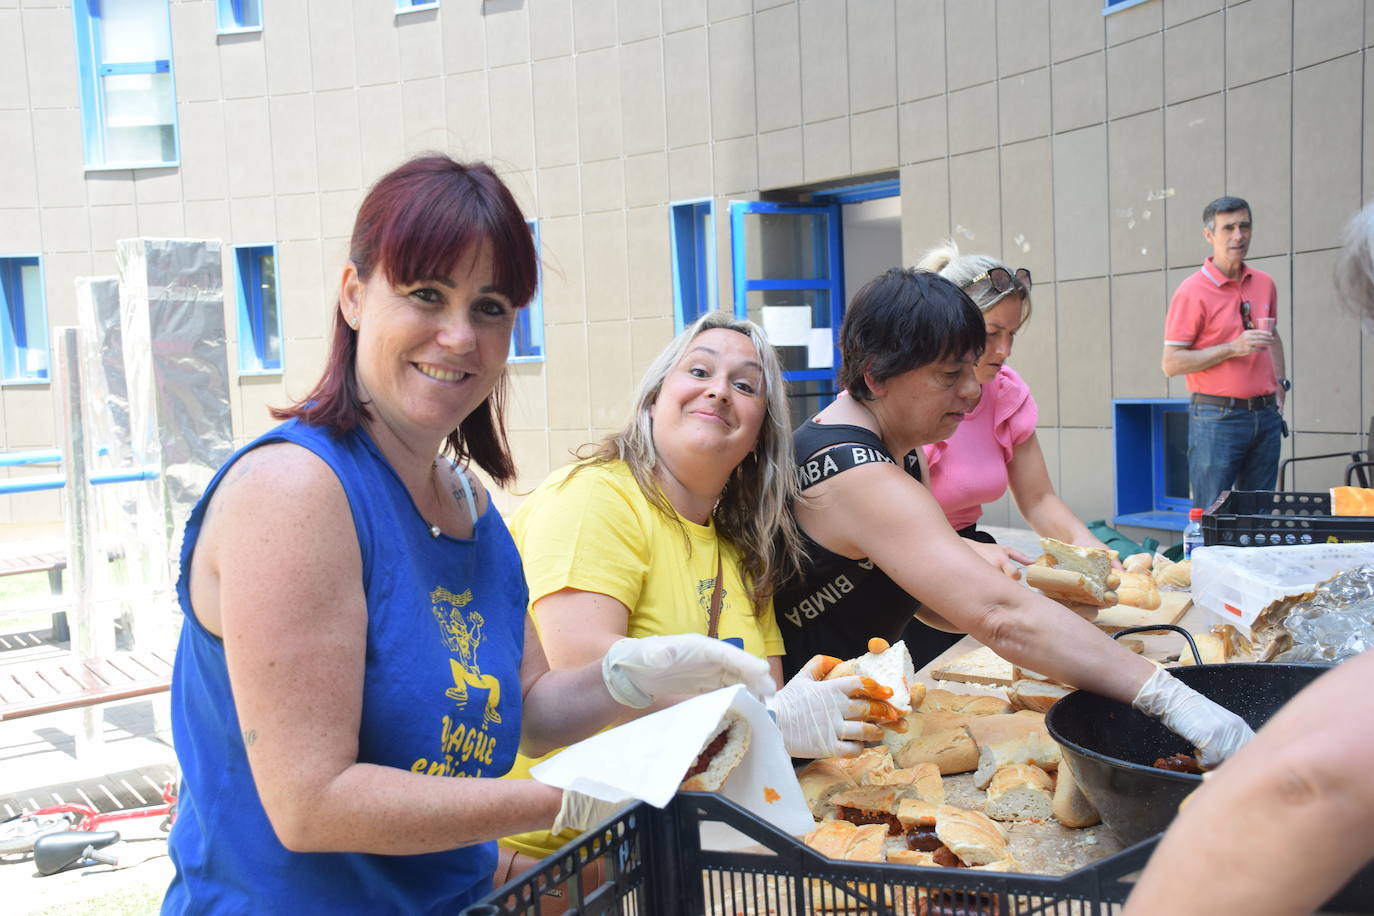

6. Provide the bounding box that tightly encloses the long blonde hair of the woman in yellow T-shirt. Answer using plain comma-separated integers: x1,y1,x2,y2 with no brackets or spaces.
573,312,801,614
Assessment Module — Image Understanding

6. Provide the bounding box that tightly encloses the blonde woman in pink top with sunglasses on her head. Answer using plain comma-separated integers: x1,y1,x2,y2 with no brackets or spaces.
916,242,1106,577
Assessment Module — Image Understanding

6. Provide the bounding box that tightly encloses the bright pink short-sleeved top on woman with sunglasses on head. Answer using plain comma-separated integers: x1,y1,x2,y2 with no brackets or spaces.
923,365,1040,530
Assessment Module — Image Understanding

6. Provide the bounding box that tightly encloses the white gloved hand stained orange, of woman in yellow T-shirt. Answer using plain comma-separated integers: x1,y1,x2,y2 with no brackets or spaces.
768,655,890,757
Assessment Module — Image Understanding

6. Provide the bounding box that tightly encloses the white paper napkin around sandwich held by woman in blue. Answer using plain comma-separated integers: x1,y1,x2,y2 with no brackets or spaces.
530,684,815,849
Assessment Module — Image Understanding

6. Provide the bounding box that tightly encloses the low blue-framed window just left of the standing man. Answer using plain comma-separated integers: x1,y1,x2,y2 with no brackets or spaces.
1112,398,1193,530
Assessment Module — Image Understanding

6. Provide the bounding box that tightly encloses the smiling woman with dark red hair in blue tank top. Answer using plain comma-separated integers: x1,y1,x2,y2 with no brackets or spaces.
164,157,774,913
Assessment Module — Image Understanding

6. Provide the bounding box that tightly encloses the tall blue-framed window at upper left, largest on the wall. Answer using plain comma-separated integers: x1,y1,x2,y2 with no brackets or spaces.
71,0,180,169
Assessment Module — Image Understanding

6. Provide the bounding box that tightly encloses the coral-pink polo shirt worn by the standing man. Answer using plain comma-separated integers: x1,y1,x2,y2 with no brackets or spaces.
1164,258,1278,397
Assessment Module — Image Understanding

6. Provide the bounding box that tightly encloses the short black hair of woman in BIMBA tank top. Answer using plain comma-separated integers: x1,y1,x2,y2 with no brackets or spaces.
838,268,988,401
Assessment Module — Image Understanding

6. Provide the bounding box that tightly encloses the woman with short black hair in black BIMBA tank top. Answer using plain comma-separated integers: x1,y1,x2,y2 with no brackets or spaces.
775,268,1249,761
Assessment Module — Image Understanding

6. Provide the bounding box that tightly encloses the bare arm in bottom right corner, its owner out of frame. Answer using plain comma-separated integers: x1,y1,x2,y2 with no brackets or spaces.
1123,651,1374,916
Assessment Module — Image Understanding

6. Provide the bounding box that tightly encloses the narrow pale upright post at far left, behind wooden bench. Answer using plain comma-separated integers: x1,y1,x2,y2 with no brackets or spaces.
52,327,113,757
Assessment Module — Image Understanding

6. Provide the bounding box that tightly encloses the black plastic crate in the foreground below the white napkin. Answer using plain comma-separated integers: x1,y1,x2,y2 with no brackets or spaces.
463,792,1158,916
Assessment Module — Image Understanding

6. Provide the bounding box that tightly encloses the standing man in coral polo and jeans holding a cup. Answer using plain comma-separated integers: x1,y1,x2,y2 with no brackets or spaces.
1160,198,1292,508
